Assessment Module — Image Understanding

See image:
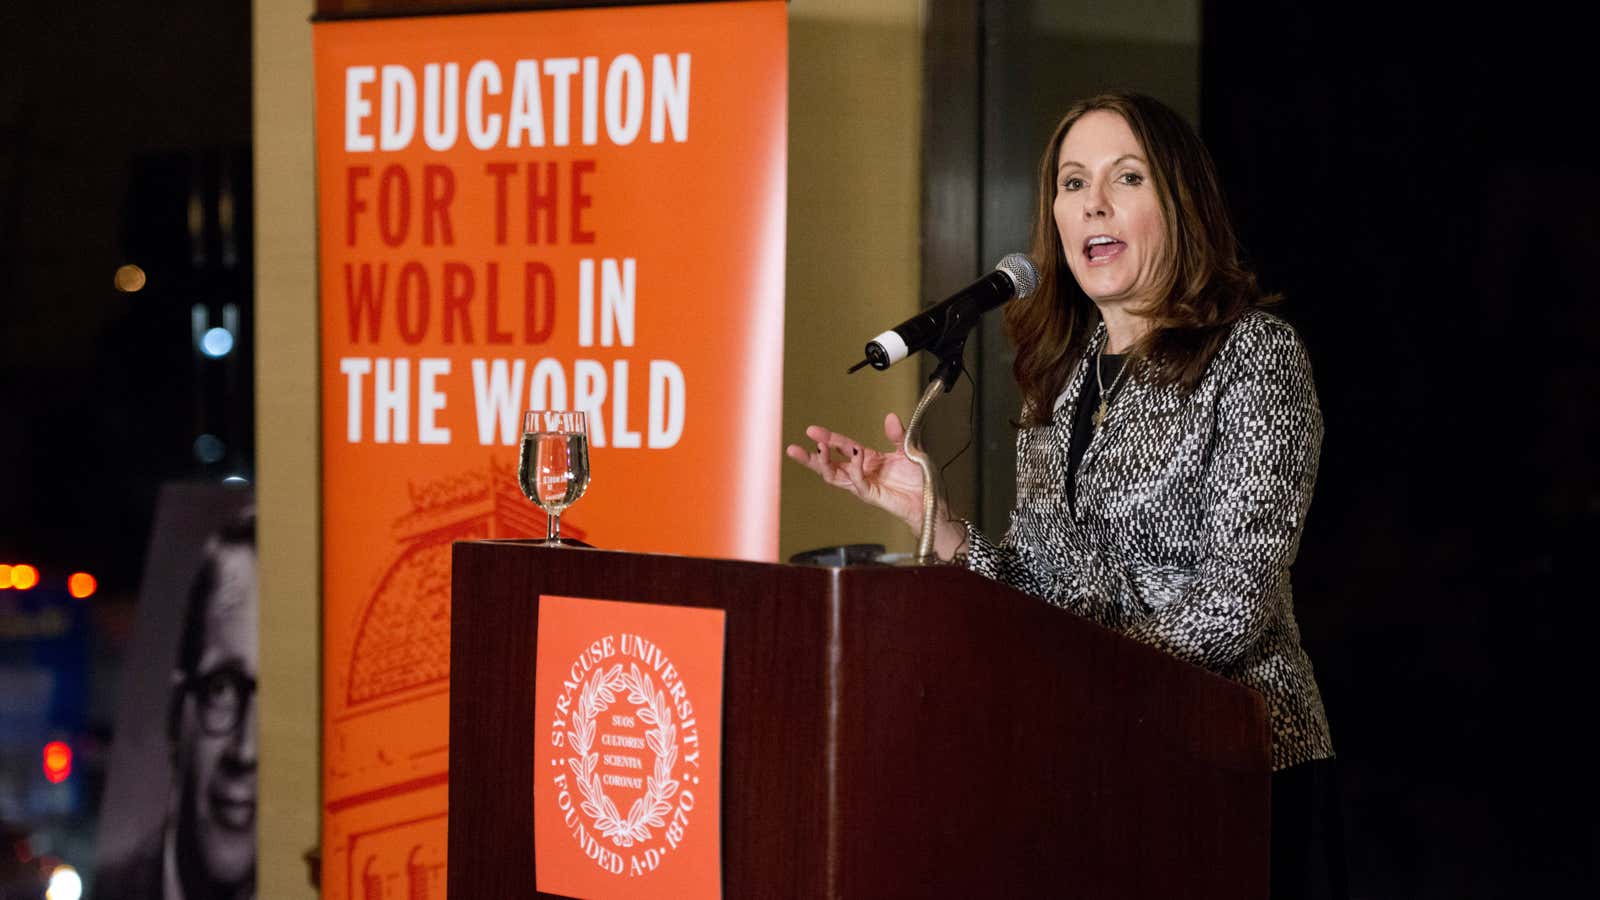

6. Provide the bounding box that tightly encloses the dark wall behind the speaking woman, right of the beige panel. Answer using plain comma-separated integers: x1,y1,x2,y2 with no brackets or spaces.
923,0,1600,898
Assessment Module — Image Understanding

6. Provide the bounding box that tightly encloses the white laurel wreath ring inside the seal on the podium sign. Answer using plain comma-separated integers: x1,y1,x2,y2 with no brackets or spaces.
566,663,678,847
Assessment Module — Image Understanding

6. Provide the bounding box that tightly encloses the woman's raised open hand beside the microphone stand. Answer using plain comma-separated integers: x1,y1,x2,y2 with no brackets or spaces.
784,413,922,533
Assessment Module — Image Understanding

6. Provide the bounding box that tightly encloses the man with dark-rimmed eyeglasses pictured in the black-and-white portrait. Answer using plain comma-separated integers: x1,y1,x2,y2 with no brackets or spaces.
96,511,258,900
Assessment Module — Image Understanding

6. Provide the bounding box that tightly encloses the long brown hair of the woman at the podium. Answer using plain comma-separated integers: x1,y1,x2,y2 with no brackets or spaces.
1005,93,1278,426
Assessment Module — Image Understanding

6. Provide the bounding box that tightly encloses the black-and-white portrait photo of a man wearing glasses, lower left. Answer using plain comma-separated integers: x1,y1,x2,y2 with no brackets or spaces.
93,485,259,900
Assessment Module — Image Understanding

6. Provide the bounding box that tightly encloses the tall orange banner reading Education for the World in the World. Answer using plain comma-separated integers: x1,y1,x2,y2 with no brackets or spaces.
314,2,787,898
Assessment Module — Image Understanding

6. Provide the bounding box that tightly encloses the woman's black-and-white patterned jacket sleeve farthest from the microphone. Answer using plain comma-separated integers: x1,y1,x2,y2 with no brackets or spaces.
1125,322,1323,671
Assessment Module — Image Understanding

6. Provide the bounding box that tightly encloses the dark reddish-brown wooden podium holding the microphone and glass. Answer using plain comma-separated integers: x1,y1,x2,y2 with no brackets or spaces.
450,541,1270,898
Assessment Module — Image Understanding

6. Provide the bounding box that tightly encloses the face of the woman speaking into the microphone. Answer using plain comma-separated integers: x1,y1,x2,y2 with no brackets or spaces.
1054,109,1166,306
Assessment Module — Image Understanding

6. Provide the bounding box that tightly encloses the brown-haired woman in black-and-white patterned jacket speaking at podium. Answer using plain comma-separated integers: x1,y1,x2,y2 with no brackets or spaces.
787,94,1342,897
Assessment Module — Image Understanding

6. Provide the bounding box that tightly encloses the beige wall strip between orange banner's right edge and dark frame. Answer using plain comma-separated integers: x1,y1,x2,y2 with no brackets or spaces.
779,0,923,559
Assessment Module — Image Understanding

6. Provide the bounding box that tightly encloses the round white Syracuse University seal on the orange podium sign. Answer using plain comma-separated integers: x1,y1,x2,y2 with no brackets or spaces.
550,633,701,878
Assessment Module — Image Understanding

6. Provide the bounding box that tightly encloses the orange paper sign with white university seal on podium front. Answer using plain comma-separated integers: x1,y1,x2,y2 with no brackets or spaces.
533,596,726,900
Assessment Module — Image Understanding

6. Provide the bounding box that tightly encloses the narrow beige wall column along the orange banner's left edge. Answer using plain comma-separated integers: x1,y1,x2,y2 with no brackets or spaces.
253,0,322,898
